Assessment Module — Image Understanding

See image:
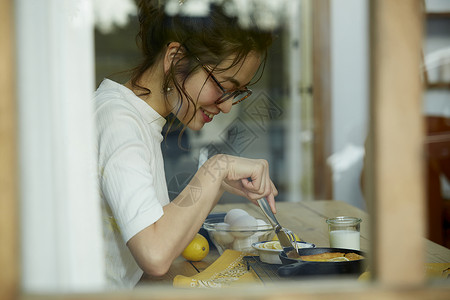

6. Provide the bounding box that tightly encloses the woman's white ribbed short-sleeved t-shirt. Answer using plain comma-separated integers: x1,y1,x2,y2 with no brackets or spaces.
94,79,169,288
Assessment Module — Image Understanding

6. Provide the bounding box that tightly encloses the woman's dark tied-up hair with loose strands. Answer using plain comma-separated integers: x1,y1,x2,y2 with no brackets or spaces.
131,0,272,133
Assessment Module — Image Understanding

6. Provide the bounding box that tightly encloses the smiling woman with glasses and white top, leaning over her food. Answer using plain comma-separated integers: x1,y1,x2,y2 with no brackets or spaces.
95,0,278,287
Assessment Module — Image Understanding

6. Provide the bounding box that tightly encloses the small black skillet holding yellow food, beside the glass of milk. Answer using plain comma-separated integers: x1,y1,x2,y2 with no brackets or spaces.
278,248,367,277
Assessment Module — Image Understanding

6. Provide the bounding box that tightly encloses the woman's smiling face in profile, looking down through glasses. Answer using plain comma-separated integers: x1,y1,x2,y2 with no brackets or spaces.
176,52,260,130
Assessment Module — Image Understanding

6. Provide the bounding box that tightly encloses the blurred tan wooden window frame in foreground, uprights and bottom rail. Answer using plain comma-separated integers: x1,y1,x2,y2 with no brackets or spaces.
0,0,449,300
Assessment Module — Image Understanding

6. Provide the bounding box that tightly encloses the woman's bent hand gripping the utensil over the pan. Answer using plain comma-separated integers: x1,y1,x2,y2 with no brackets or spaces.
205,154,278,213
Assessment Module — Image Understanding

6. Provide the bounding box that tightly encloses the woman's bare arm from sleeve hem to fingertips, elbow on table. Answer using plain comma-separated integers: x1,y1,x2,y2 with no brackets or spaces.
127,154,278,276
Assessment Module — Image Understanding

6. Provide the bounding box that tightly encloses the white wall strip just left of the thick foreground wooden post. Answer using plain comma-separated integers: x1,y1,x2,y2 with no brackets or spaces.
330,0,369,209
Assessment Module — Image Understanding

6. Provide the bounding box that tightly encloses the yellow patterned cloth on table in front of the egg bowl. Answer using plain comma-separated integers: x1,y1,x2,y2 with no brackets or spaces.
173,250,262,288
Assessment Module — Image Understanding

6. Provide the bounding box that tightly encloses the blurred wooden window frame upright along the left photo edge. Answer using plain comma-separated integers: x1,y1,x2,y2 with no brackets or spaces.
0,0,20,299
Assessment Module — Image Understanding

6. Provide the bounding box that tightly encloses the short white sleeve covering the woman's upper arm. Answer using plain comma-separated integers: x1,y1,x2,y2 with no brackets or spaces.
96,101,163,243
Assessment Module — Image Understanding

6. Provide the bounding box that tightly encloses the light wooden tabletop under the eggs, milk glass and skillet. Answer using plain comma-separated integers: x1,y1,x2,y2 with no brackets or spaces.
140,200,450,285
